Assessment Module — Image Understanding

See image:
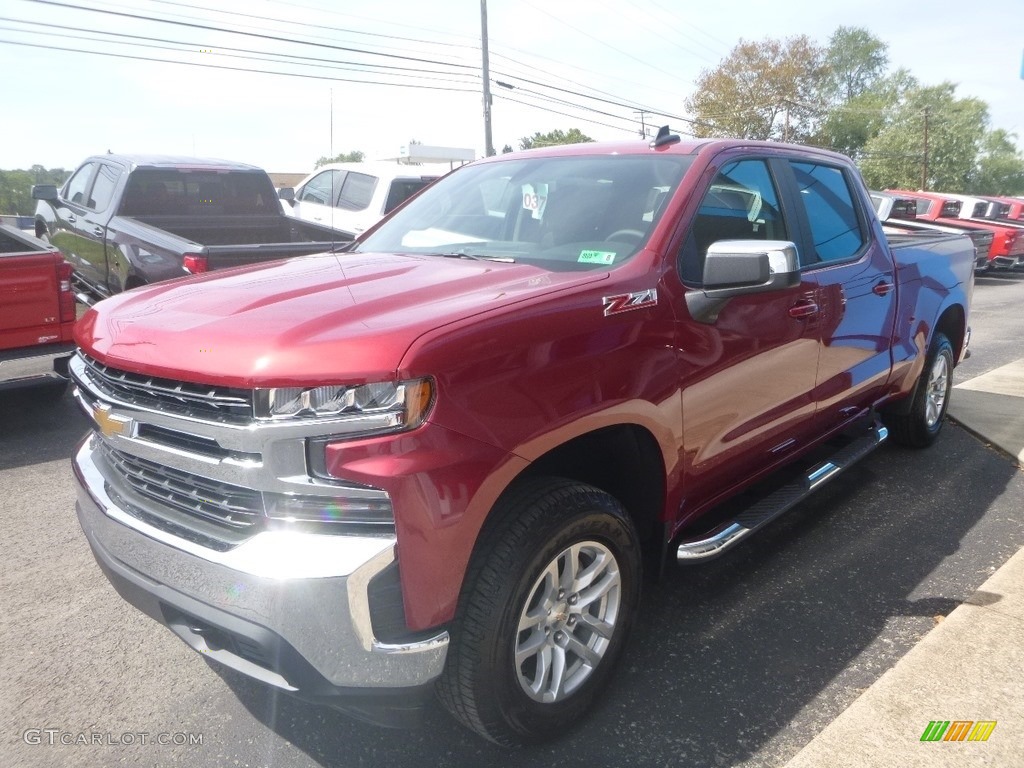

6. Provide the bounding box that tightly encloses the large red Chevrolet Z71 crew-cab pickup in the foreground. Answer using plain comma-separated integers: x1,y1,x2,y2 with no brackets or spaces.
71,131,974,743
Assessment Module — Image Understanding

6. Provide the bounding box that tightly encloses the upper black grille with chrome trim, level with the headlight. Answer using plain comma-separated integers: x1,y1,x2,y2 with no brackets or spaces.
78,351,253,424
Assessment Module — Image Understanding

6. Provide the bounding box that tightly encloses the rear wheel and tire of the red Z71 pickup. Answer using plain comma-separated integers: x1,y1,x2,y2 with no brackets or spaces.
884,333,953,447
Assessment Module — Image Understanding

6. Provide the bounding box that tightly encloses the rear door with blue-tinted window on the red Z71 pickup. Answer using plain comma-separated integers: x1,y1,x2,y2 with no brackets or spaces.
788,160,896,430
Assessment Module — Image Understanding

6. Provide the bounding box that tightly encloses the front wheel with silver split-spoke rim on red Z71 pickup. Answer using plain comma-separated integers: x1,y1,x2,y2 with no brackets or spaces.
437,478,641,745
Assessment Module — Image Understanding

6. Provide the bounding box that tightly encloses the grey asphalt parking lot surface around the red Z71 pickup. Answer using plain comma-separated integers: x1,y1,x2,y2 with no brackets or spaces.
0,272,1024,768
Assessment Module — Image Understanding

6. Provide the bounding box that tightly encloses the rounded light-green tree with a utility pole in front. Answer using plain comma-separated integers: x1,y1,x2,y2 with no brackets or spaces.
860,82,988,191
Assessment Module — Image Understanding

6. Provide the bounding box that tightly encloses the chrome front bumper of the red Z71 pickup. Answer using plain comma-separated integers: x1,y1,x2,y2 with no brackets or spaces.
74,435,449,724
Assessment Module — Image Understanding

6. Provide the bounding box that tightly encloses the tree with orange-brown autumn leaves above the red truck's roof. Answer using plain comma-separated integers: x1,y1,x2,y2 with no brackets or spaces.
685,35,826,141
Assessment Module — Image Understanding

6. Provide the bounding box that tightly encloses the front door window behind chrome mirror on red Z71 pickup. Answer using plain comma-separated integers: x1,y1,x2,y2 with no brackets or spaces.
680,160,790,285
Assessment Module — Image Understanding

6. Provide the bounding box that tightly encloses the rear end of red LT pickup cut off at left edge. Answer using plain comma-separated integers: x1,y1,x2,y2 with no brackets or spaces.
0,224,75,396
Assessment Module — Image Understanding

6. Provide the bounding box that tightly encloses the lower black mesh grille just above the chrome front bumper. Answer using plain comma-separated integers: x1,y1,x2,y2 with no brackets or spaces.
101,443,263,529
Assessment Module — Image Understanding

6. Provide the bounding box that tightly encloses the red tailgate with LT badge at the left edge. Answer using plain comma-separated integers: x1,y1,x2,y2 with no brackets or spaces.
0,229,61,349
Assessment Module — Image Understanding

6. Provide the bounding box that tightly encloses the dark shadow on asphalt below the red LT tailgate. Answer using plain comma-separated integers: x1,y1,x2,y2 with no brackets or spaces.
0,385,89,470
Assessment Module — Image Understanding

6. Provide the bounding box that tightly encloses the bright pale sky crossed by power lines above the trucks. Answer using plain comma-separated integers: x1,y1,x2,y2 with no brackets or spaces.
0,0,1024,173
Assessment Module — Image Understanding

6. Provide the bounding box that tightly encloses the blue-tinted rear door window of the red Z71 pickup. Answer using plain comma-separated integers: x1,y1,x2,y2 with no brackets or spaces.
792,162,864,261
